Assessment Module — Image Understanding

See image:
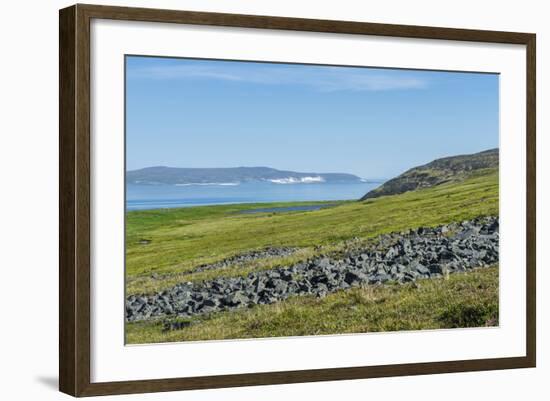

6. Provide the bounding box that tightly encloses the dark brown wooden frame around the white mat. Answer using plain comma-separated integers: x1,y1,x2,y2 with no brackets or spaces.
59,4,536,396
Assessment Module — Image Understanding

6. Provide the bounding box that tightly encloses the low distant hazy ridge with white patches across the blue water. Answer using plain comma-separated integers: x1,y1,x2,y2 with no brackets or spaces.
126,166,365,185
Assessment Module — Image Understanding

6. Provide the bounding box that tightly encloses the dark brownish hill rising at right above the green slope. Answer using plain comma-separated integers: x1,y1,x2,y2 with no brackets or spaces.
360,148,499,200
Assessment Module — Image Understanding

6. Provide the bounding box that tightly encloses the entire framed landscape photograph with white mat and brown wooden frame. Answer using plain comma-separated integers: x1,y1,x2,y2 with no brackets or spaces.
59,5,536,396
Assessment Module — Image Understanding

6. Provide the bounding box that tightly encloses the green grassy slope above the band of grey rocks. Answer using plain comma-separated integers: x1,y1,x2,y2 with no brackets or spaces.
126,170,498,294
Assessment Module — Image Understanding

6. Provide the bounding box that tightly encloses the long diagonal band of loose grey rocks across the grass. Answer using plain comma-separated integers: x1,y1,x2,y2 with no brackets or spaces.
126,217,499,321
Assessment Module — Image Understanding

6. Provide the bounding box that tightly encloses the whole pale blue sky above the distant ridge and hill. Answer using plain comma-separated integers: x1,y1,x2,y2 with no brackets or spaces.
126,56,499,178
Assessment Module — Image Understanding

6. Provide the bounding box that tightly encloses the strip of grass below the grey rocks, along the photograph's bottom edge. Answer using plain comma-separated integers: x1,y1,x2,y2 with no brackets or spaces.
126,266,498,344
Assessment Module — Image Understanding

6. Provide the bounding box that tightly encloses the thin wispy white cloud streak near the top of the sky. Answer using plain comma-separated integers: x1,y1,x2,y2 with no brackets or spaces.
129,62,427,92
